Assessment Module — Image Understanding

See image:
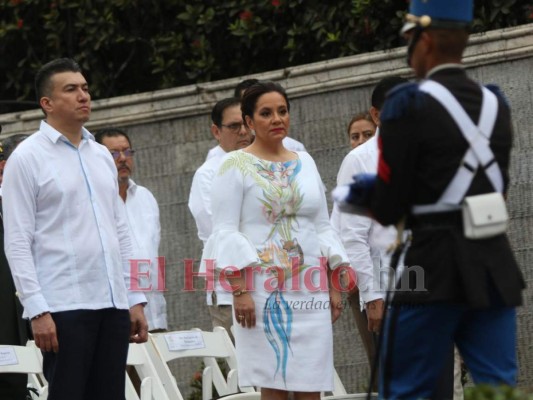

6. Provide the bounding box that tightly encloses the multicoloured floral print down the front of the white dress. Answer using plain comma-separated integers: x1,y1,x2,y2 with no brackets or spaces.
219,151,307,381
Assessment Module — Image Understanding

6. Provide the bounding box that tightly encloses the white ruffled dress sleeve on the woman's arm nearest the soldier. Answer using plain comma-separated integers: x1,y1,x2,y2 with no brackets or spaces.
301,153,350,269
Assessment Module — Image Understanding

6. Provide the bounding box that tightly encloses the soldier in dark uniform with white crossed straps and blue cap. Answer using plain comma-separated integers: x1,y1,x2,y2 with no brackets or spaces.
337,0,524,399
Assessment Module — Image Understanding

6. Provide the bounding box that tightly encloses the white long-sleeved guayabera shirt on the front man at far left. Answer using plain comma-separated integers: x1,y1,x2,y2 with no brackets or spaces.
2,121,146,318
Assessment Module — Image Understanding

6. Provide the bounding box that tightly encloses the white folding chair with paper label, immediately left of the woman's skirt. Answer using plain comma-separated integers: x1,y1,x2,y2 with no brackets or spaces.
150,327,243,400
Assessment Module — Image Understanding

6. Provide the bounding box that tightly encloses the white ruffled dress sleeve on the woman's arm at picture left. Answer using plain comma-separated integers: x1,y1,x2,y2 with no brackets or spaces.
200,152,259,272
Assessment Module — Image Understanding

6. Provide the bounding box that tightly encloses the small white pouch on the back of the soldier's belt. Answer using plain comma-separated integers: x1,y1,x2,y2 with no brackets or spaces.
462,192,509,239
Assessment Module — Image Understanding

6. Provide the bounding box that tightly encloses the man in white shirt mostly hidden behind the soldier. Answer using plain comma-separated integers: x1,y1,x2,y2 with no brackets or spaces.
331,77,407,388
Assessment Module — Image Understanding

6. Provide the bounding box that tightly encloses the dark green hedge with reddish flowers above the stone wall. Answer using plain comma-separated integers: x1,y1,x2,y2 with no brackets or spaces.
0,0,533,112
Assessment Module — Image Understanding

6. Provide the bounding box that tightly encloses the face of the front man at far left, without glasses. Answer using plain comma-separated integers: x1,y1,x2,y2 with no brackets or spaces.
41,72,91,124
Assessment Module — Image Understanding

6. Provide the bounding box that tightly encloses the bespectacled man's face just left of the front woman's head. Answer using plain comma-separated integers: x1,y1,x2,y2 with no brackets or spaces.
211,105,252,153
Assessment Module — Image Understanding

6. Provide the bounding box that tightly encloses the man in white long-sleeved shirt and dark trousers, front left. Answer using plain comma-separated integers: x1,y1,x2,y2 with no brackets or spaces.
3,58,148,400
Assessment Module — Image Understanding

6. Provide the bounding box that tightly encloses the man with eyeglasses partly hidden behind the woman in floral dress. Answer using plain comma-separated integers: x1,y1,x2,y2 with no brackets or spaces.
189,97,252,339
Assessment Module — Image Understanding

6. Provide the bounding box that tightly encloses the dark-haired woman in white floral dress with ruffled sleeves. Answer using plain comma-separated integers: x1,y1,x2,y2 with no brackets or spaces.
203,82,353,400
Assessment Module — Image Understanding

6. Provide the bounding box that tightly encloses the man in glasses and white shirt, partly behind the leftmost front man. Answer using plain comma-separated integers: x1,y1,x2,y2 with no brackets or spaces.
95,128,168,332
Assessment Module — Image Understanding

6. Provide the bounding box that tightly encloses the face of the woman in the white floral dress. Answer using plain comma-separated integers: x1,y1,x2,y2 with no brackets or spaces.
246,92,289,142
